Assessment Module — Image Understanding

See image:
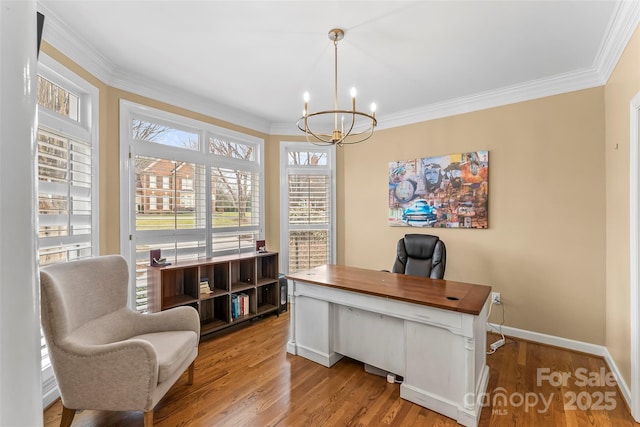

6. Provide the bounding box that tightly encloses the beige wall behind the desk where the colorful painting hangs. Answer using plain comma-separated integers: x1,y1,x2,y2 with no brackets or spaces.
338,87,605,345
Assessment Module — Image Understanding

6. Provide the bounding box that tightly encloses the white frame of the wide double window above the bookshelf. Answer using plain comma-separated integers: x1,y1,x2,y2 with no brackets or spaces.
120,100,265,310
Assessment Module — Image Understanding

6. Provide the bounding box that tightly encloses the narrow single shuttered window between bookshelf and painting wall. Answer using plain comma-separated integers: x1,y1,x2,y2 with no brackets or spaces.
280,143,335,273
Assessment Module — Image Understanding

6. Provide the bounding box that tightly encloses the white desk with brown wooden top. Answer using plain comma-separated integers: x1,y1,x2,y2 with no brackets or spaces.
286,265,491,426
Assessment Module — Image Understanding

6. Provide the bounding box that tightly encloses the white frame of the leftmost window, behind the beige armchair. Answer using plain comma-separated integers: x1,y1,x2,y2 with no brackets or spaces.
35,52,100,407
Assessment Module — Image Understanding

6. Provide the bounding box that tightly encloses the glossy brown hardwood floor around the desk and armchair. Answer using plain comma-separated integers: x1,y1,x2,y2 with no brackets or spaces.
44,313,640,427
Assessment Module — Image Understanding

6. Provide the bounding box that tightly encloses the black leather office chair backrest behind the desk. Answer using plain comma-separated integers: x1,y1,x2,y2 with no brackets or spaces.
392,234,447,279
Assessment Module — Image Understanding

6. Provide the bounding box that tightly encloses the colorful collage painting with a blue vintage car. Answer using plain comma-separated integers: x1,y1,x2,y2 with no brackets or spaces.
389,150,489,228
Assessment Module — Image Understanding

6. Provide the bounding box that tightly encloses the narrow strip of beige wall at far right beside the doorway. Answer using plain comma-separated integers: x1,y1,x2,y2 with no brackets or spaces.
605,23,640,384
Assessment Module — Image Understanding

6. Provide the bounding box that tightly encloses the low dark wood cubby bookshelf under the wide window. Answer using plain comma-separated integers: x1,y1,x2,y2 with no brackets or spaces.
147,252,280,335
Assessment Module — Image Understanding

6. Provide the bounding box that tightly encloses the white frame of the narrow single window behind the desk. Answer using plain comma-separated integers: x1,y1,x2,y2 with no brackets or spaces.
280,141,337,274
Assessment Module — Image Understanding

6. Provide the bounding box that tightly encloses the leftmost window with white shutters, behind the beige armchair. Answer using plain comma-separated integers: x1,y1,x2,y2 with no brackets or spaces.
36,52,99,406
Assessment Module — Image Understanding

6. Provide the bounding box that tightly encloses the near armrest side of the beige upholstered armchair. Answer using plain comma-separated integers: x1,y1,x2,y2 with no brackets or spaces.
55,340,158,411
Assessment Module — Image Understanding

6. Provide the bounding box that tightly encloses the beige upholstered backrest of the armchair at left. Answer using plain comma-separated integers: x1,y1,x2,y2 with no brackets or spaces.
40,255,129,341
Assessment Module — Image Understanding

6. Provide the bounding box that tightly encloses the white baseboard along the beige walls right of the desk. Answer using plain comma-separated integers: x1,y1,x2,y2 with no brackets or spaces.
487,323,631,414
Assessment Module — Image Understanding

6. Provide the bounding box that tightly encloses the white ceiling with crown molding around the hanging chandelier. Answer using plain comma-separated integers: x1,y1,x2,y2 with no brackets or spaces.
38,0,638,133
